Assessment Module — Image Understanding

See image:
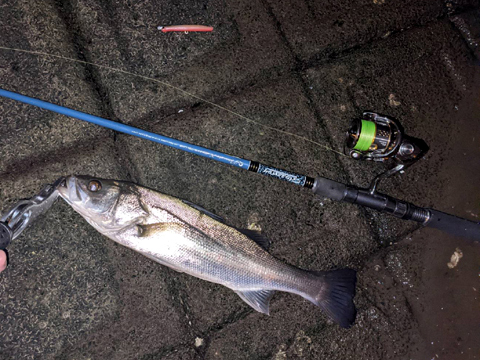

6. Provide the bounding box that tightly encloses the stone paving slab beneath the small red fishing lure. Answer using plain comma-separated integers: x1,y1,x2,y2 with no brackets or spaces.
65,0,293,122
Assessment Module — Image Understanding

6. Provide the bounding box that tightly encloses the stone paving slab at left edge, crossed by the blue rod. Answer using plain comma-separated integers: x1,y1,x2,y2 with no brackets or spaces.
0,2,119,200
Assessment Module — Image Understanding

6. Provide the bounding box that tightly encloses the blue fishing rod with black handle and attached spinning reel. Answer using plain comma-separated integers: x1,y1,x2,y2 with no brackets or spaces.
0,89,480,241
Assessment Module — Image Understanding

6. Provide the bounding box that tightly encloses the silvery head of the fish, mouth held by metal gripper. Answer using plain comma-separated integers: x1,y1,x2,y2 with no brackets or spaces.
58,175,148,233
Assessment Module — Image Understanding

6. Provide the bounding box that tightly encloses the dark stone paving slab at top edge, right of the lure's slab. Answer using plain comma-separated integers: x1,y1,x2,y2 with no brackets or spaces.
268,0,445,62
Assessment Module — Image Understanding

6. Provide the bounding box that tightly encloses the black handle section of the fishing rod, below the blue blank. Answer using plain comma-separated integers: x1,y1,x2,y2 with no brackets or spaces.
312,177,480,241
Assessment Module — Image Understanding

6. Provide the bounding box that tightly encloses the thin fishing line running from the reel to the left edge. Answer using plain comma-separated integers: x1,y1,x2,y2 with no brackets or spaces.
0,46,345,156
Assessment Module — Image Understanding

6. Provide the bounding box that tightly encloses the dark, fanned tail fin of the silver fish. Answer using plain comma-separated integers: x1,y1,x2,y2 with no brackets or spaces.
309,269,357,328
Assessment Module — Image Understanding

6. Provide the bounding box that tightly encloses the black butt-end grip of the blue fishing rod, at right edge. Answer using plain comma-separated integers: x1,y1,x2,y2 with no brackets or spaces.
425,209,480,241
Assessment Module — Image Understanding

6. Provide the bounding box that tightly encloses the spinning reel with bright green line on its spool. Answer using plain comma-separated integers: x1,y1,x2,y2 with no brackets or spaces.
344,112,428,194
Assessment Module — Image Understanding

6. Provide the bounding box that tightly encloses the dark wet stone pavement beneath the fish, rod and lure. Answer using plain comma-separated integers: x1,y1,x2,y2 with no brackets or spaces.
0,0,480,360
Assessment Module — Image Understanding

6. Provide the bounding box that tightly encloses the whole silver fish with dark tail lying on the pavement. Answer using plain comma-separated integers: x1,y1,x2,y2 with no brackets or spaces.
58,175,356,328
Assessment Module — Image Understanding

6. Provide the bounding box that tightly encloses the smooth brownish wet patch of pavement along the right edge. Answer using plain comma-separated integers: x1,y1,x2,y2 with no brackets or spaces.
404,71,480,360
